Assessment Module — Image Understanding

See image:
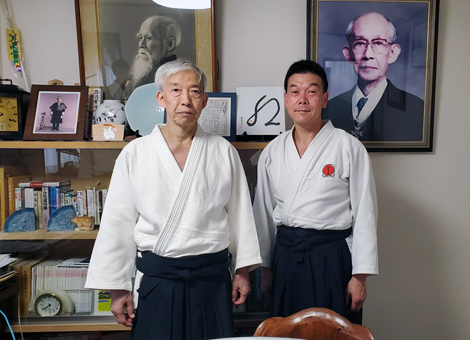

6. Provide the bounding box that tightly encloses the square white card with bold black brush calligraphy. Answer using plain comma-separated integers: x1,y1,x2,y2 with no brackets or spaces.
237,86,286,136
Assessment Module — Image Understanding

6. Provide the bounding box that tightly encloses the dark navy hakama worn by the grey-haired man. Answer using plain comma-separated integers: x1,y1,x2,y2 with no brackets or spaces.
132,250,233,340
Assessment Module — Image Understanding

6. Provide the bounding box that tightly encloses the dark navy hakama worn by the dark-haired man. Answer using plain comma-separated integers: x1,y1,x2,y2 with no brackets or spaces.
272,226,362,324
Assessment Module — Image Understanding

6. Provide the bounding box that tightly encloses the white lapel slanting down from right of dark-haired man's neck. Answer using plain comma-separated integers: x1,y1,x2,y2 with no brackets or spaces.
281,121,334,226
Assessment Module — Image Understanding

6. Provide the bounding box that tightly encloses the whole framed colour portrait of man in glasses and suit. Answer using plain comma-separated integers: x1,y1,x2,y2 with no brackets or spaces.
307,0,438,152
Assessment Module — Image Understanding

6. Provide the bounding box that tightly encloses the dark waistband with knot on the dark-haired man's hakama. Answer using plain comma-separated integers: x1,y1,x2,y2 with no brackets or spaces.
276,225,352,262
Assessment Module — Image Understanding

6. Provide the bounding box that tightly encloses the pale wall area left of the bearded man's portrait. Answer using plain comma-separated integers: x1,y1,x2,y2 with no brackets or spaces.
0,0,80,91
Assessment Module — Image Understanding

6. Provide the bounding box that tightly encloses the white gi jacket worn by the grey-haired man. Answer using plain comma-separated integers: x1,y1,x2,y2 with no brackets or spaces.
85,126,261,291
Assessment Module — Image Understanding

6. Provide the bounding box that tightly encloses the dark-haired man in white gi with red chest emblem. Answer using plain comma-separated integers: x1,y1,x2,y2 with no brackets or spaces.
254,60,378,323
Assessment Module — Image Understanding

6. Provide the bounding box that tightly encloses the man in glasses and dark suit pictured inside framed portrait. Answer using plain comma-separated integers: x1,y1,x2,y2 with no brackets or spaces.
323,13,424,141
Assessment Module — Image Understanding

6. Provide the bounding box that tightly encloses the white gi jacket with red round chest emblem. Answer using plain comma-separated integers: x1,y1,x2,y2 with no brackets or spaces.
253,121,379,274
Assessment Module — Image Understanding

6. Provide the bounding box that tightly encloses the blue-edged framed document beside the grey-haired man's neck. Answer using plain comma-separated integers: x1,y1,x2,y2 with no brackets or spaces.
198,92,237,141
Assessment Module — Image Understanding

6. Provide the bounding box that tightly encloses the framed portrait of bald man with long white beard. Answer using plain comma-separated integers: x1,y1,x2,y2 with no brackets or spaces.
76,0,215,101
